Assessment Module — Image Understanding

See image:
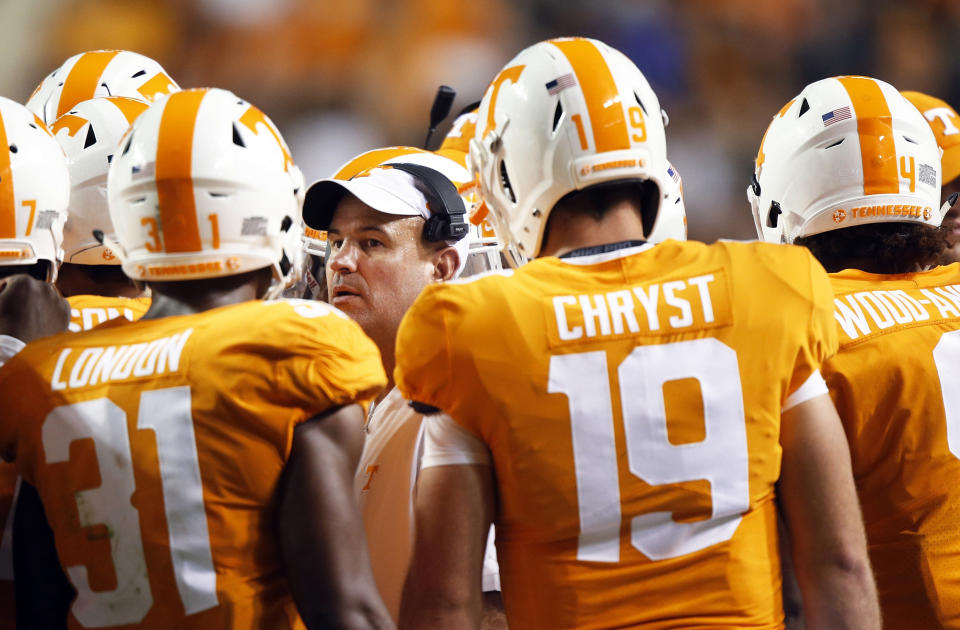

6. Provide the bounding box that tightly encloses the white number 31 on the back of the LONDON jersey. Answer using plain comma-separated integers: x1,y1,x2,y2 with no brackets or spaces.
42,387,217,628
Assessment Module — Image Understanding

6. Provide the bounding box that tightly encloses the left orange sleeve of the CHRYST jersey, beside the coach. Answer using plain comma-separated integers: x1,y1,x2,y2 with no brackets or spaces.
393,285,455,412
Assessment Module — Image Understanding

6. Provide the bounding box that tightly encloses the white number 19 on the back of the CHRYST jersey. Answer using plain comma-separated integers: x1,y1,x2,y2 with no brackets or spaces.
548,338,750,562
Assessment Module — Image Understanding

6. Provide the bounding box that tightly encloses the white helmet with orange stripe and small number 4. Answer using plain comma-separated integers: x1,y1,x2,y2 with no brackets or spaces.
747,76,945,243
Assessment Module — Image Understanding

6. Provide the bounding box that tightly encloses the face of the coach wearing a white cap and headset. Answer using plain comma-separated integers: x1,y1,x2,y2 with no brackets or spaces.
326,194,457,358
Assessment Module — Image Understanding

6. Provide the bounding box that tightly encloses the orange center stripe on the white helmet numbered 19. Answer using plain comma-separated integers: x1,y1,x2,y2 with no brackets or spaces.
551,39,632,153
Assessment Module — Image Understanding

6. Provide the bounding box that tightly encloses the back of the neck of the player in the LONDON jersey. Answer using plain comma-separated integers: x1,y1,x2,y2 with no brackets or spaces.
143,268,270,319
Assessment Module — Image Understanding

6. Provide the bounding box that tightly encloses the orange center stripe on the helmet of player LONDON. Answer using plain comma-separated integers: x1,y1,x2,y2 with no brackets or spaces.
156,90,207,253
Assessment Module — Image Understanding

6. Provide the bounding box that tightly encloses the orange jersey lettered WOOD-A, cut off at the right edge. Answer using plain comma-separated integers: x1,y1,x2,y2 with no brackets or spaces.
823,264,960,628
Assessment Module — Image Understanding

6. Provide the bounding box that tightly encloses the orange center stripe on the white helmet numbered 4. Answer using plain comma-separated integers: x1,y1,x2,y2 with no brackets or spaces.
837,77,900,195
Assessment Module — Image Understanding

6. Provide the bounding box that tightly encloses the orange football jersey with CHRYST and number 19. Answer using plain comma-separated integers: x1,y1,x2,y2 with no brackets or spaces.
396,241,836,630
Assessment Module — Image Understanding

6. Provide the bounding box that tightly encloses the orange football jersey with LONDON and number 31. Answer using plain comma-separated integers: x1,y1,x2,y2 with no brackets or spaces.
0,301,386,630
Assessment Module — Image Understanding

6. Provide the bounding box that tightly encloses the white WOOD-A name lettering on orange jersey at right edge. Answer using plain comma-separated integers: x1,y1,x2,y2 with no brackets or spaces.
833,284,960,339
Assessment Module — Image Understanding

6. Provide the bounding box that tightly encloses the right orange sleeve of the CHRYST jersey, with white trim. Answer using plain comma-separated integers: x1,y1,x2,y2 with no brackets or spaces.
783,249,839,407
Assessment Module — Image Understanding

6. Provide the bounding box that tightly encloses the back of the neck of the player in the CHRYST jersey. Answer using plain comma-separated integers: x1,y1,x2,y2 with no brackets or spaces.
538,202,646,256
